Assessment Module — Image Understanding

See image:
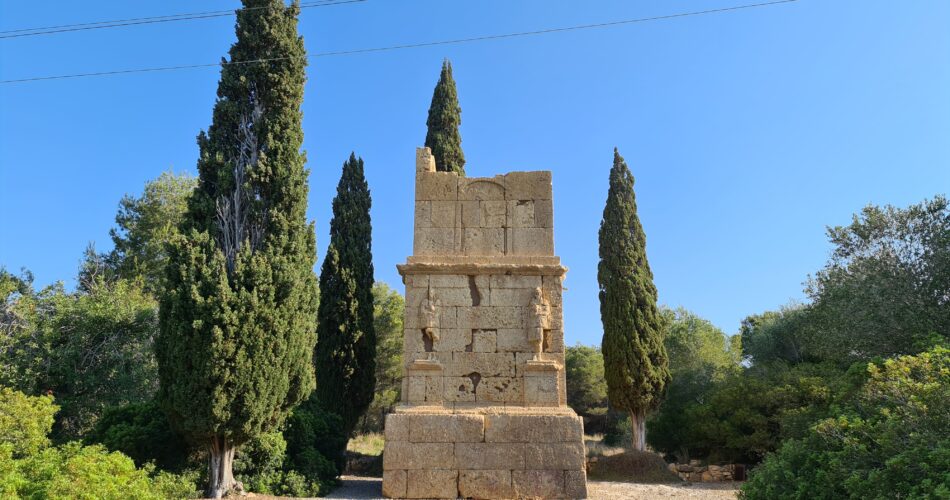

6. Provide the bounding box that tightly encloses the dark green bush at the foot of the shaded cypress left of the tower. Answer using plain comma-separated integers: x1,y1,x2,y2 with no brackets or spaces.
284,399,347,484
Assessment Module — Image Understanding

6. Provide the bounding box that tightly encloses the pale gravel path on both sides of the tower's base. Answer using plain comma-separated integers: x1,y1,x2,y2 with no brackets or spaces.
326,476,736,500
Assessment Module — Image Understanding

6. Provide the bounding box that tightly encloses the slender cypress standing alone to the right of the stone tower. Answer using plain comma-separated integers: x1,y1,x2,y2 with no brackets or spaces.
597,148,670,450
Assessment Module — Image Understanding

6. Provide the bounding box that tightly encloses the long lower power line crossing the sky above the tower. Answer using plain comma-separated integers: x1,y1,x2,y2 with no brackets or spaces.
0,0,798,84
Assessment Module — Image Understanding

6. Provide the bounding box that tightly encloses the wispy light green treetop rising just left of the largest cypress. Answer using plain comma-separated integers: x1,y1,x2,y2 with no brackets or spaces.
108,171,197,293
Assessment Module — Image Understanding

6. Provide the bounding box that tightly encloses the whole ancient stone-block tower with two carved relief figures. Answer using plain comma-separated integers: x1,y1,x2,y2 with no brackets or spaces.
383,148,587,498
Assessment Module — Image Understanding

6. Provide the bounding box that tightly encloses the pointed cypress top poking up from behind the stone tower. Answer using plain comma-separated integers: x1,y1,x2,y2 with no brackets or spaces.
425,59,465,176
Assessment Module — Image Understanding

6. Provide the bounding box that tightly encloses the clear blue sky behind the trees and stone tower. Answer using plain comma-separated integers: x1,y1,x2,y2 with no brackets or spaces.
0,0,950,344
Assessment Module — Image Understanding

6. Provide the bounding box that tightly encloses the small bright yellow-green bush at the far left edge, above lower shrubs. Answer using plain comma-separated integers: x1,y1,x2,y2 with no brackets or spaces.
0,386,59,457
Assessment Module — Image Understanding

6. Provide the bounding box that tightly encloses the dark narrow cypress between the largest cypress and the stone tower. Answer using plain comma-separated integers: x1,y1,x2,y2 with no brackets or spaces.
314,154,376,453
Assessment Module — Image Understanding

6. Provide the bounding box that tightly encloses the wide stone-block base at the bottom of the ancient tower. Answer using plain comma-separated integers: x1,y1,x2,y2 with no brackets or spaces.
383,405,587,498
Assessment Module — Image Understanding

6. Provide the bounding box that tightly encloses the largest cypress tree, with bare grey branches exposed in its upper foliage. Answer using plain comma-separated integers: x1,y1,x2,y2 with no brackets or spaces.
155,0,317,497
